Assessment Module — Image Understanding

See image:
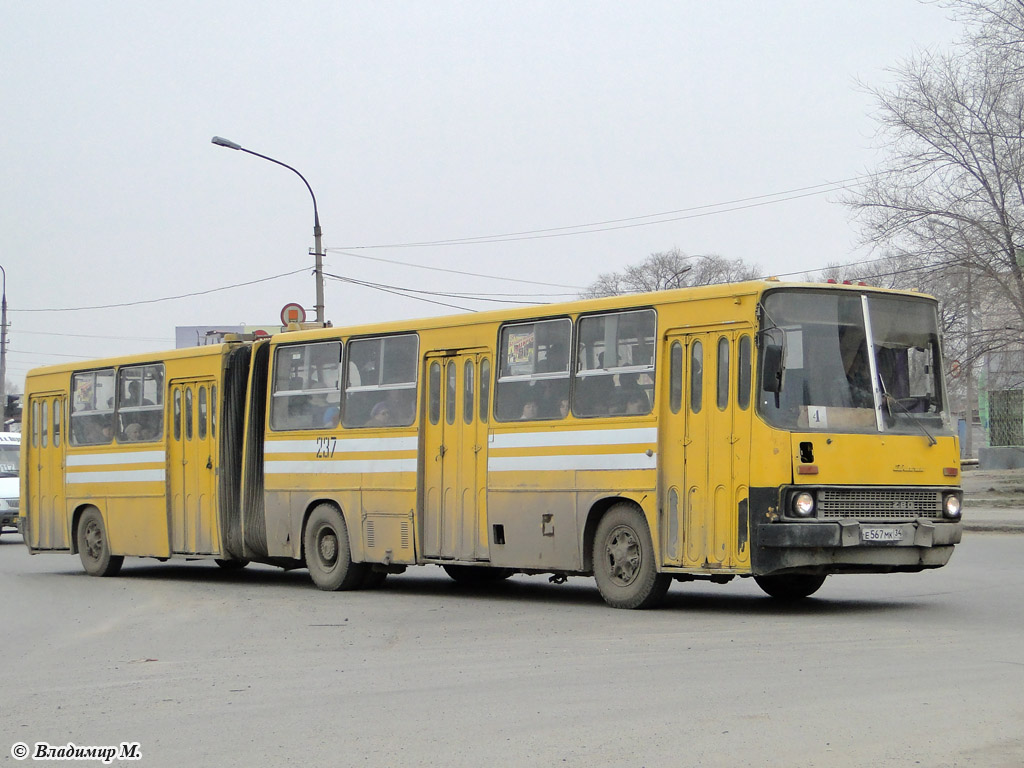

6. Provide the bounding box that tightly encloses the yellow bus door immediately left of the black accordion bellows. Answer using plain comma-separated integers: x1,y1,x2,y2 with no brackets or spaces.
167,379,219,554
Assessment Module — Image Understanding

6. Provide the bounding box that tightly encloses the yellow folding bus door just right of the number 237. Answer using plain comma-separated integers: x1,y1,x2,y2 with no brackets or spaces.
423,351,490,560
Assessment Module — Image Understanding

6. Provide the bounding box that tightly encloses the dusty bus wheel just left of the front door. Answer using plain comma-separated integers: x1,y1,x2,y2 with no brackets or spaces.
593,504,672,608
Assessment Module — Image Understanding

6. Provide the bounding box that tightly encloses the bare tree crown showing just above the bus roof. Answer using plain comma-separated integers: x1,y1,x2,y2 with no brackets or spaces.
580,248,760,299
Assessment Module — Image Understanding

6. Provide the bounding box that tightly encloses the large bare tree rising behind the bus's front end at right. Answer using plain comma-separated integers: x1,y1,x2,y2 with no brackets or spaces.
846,0,1024,423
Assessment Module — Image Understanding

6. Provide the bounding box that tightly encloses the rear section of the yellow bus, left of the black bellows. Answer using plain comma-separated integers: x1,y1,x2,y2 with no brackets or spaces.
22,344,248,575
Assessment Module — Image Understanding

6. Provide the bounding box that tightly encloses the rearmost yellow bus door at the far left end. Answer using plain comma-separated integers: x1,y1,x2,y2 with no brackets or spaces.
22,392,71,549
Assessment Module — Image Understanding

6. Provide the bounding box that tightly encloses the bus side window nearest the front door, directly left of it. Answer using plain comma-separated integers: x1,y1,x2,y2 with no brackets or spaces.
572,309,656,416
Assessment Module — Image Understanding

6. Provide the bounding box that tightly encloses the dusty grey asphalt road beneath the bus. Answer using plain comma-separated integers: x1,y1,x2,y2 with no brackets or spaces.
0,531,1024,768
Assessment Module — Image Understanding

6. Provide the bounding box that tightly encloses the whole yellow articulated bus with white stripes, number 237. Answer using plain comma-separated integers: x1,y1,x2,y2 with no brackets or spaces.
20,281,963,608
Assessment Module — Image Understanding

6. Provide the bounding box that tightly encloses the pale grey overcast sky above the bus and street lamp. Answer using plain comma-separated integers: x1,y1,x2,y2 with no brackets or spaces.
0,0,959,388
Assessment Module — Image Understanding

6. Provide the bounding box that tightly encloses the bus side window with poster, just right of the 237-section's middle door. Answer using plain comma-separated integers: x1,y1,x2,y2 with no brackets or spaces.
495,317,572,421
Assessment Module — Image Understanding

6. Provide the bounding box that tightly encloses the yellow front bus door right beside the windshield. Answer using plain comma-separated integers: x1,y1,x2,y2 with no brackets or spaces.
659,329,751,569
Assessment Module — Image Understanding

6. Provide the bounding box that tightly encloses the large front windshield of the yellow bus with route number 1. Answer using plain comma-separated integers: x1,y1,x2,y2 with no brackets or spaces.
759,290,950,436
